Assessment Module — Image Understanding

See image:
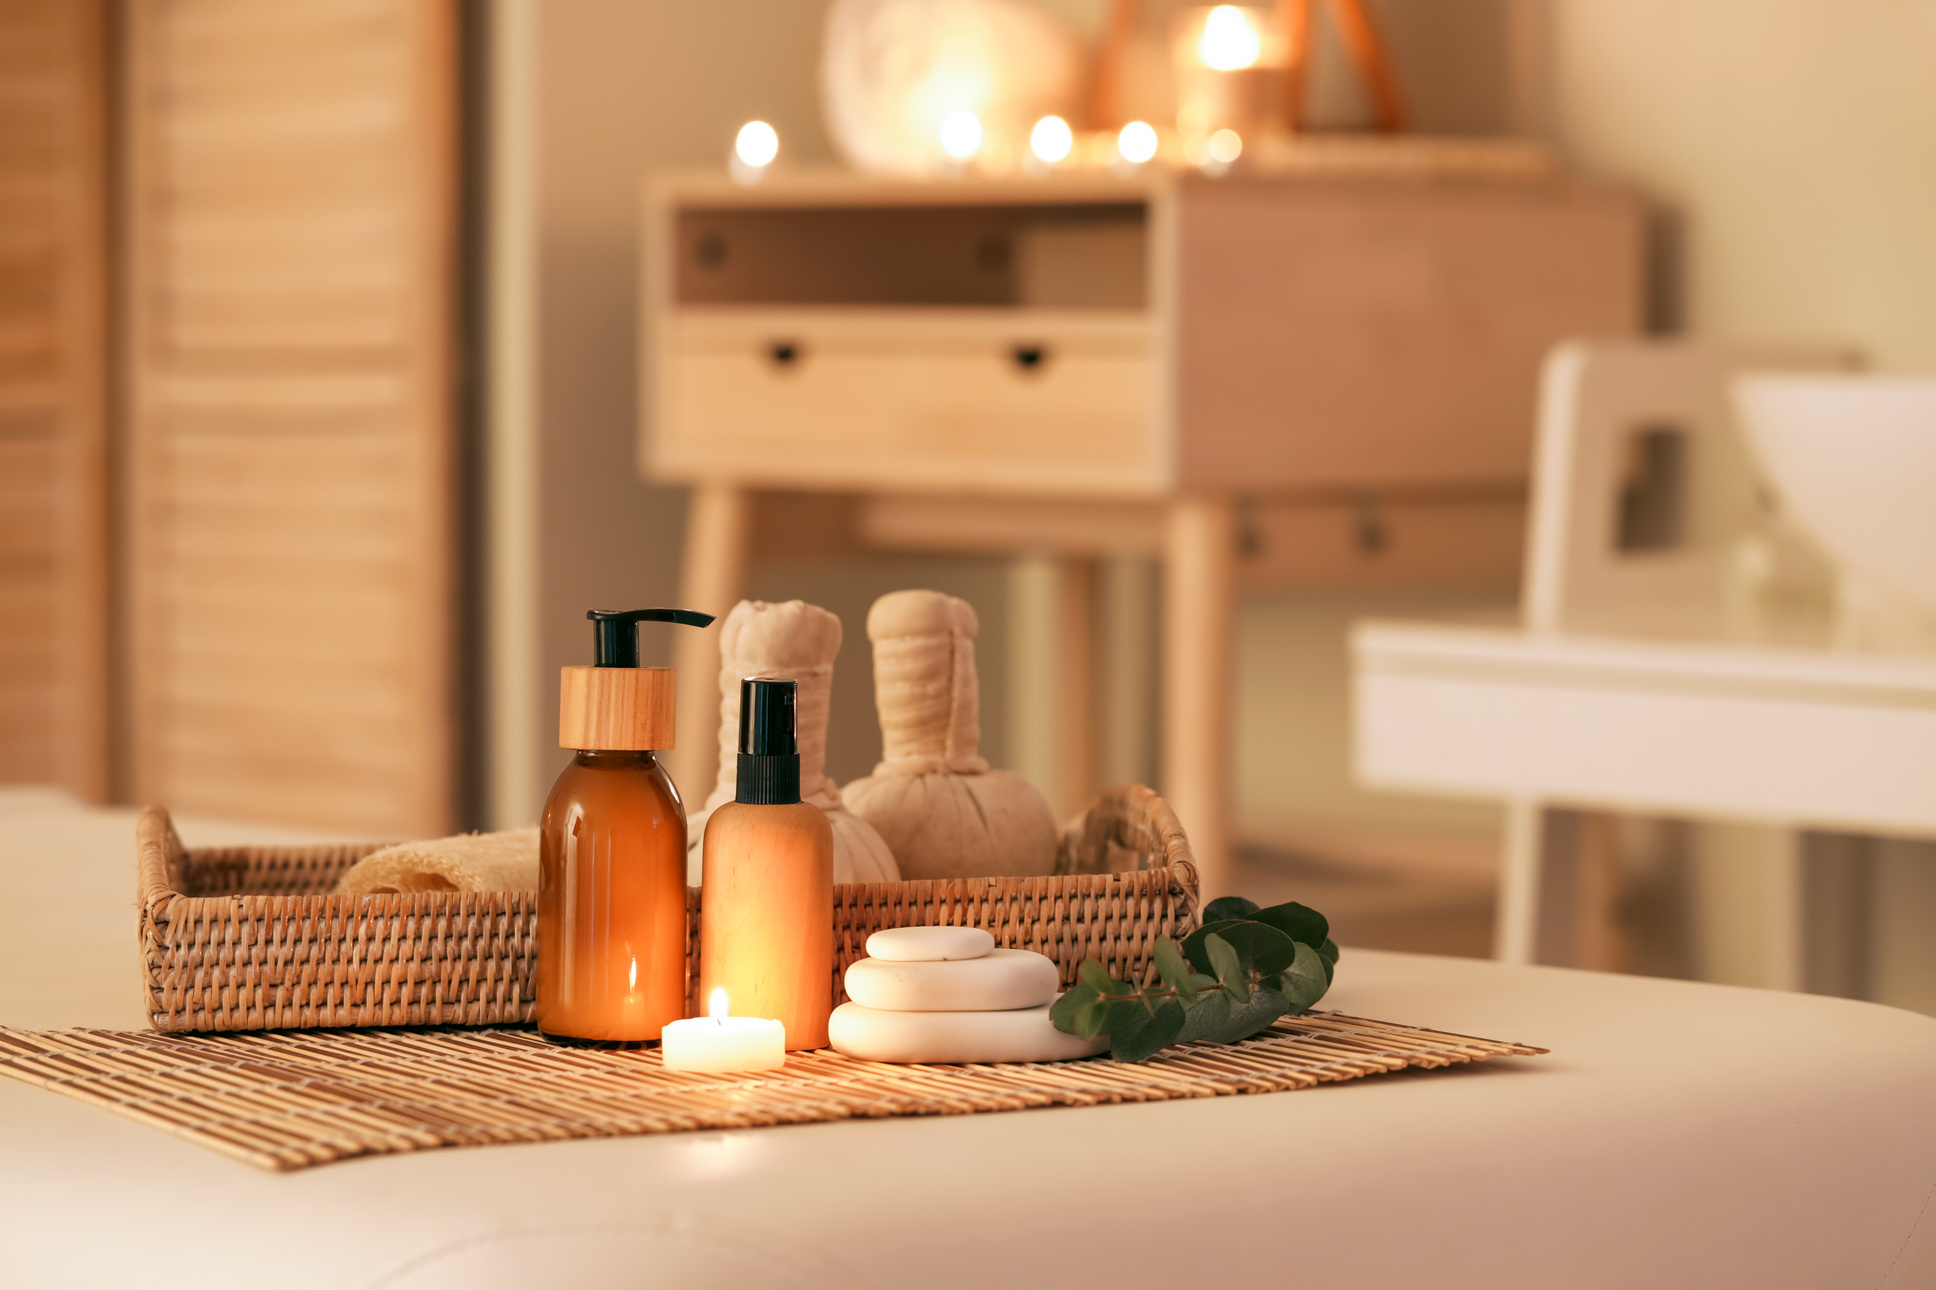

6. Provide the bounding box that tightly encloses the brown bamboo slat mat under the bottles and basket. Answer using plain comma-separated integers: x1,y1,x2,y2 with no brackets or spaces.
0,1013,1545,1170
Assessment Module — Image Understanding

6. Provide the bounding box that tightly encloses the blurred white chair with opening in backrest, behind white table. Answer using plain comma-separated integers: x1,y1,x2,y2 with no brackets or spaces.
1495,339,1859,967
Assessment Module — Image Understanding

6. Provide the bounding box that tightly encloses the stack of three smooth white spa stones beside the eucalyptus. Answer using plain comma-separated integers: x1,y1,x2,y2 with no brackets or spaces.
827,928,1109,1063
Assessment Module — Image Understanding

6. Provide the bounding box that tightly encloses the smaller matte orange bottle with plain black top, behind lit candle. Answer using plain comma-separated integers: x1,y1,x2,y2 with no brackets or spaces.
699,676,834,1048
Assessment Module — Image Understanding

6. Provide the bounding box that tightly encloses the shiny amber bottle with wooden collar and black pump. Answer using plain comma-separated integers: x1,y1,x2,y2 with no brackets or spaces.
538,610,712,1048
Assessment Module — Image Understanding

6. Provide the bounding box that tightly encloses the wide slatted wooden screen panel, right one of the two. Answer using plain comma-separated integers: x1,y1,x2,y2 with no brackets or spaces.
128,0,457,837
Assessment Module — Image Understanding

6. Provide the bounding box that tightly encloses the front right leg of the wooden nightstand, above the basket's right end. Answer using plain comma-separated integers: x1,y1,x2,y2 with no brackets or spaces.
1164,498,1237,901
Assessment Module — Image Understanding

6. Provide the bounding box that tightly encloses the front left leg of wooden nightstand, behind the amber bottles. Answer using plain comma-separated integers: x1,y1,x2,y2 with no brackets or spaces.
666,482,749,810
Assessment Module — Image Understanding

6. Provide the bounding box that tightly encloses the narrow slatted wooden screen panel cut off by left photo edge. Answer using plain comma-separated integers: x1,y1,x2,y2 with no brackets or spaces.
0,0,106,800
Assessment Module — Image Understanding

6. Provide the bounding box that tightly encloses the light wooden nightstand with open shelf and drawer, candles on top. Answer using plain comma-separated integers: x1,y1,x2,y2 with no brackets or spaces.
641,153,1644,893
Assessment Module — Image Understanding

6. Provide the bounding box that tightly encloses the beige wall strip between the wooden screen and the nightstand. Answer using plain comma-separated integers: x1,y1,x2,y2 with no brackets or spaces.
534,0,832,802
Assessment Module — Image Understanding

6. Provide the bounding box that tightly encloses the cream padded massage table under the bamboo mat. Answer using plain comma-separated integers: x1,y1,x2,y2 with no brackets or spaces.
0,790,1936,1290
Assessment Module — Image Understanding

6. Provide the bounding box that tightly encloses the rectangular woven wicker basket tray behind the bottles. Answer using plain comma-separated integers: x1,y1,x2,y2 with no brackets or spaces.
136,786,1196,1030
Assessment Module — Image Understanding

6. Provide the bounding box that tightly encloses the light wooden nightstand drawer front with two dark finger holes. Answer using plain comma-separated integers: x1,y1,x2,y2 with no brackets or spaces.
652,310,1167,494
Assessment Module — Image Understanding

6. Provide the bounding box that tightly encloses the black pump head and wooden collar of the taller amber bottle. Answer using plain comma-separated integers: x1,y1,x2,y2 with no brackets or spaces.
558,610,712,752
